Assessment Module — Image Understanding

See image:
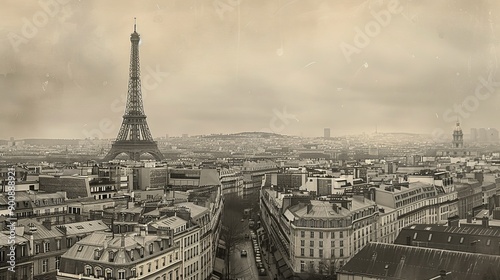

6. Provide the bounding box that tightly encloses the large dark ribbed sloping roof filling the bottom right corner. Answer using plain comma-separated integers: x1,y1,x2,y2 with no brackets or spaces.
341,243,500,280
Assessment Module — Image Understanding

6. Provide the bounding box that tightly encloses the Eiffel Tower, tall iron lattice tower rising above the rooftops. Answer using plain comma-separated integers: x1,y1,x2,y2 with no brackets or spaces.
104,19,163,161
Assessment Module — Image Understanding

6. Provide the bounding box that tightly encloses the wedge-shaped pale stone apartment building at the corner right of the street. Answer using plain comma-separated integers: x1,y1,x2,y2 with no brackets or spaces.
261,189,379,275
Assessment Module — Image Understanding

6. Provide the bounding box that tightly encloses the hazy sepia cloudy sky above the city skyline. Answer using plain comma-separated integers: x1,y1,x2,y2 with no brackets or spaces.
0,0,500,139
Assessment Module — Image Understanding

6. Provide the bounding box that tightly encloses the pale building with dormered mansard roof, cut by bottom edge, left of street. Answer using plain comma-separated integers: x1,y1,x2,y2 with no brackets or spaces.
57,228,181,280
